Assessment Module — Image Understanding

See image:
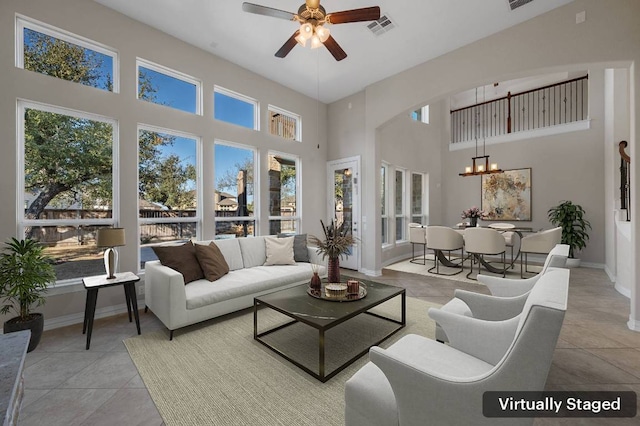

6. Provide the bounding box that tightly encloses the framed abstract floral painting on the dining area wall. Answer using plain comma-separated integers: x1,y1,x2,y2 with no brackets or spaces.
481,167,531,220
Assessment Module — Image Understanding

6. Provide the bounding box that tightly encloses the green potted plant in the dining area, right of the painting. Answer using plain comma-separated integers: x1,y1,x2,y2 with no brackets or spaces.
547,201,591,264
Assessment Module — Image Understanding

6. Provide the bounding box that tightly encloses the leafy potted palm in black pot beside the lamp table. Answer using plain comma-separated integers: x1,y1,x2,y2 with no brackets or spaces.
0,238,56,352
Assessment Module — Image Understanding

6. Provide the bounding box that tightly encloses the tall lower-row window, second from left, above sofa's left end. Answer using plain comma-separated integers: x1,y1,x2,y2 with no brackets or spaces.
138,126,200,269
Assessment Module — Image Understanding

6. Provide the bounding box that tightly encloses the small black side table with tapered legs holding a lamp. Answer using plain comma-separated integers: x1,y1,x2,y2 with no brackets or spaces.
82,272,140,350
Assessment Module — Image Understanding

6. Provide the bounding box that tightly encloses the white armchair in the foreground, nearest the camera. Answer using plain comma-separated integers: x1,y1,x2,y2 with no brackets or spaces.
345,269,569,426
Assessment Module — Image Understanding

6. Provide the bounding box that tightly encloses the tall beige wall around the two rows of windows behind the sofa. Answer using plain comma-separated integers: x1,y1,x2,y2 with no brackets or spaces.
0,0,327,321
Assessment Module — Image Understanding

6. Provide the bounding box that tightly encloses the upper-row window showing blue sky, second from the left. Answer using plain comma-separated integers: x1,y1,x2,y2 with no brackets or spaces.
136,59,202,114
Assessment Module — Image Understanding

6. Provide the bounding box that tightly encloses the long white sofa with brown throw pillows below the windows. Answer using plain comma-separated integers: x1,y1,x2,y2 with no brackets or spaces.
144,236,326,340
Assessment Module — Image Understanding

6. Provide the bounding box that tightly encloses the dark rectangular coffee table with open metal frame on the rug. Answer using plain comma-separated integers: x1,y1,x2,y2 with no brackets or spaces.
253,281,406,383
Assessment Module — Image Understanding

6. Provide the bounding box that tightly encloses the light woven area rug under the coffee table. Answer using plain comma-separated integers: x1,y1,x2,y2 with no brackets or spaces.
124,297,438,426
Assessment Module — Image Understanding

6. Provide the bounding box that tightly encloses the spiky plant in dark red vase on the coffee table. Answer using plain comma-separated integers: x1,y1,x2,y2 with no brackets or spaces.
311,220,356,283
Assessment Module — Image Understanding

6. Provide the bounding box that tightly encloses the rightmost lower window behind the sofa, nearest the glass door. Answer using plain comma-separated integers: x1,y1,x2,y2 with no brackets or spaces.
267,152,300,235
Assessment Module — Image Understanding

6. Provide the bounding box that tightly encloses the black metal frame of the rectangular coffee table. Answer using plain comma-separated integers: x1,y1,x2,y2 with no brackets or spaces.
253,283,407,383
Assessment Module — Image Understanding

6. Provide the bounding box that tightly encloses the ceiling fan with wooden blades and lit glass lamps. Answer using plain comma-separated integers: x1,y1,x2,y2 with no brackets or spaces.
242,0,380,61
